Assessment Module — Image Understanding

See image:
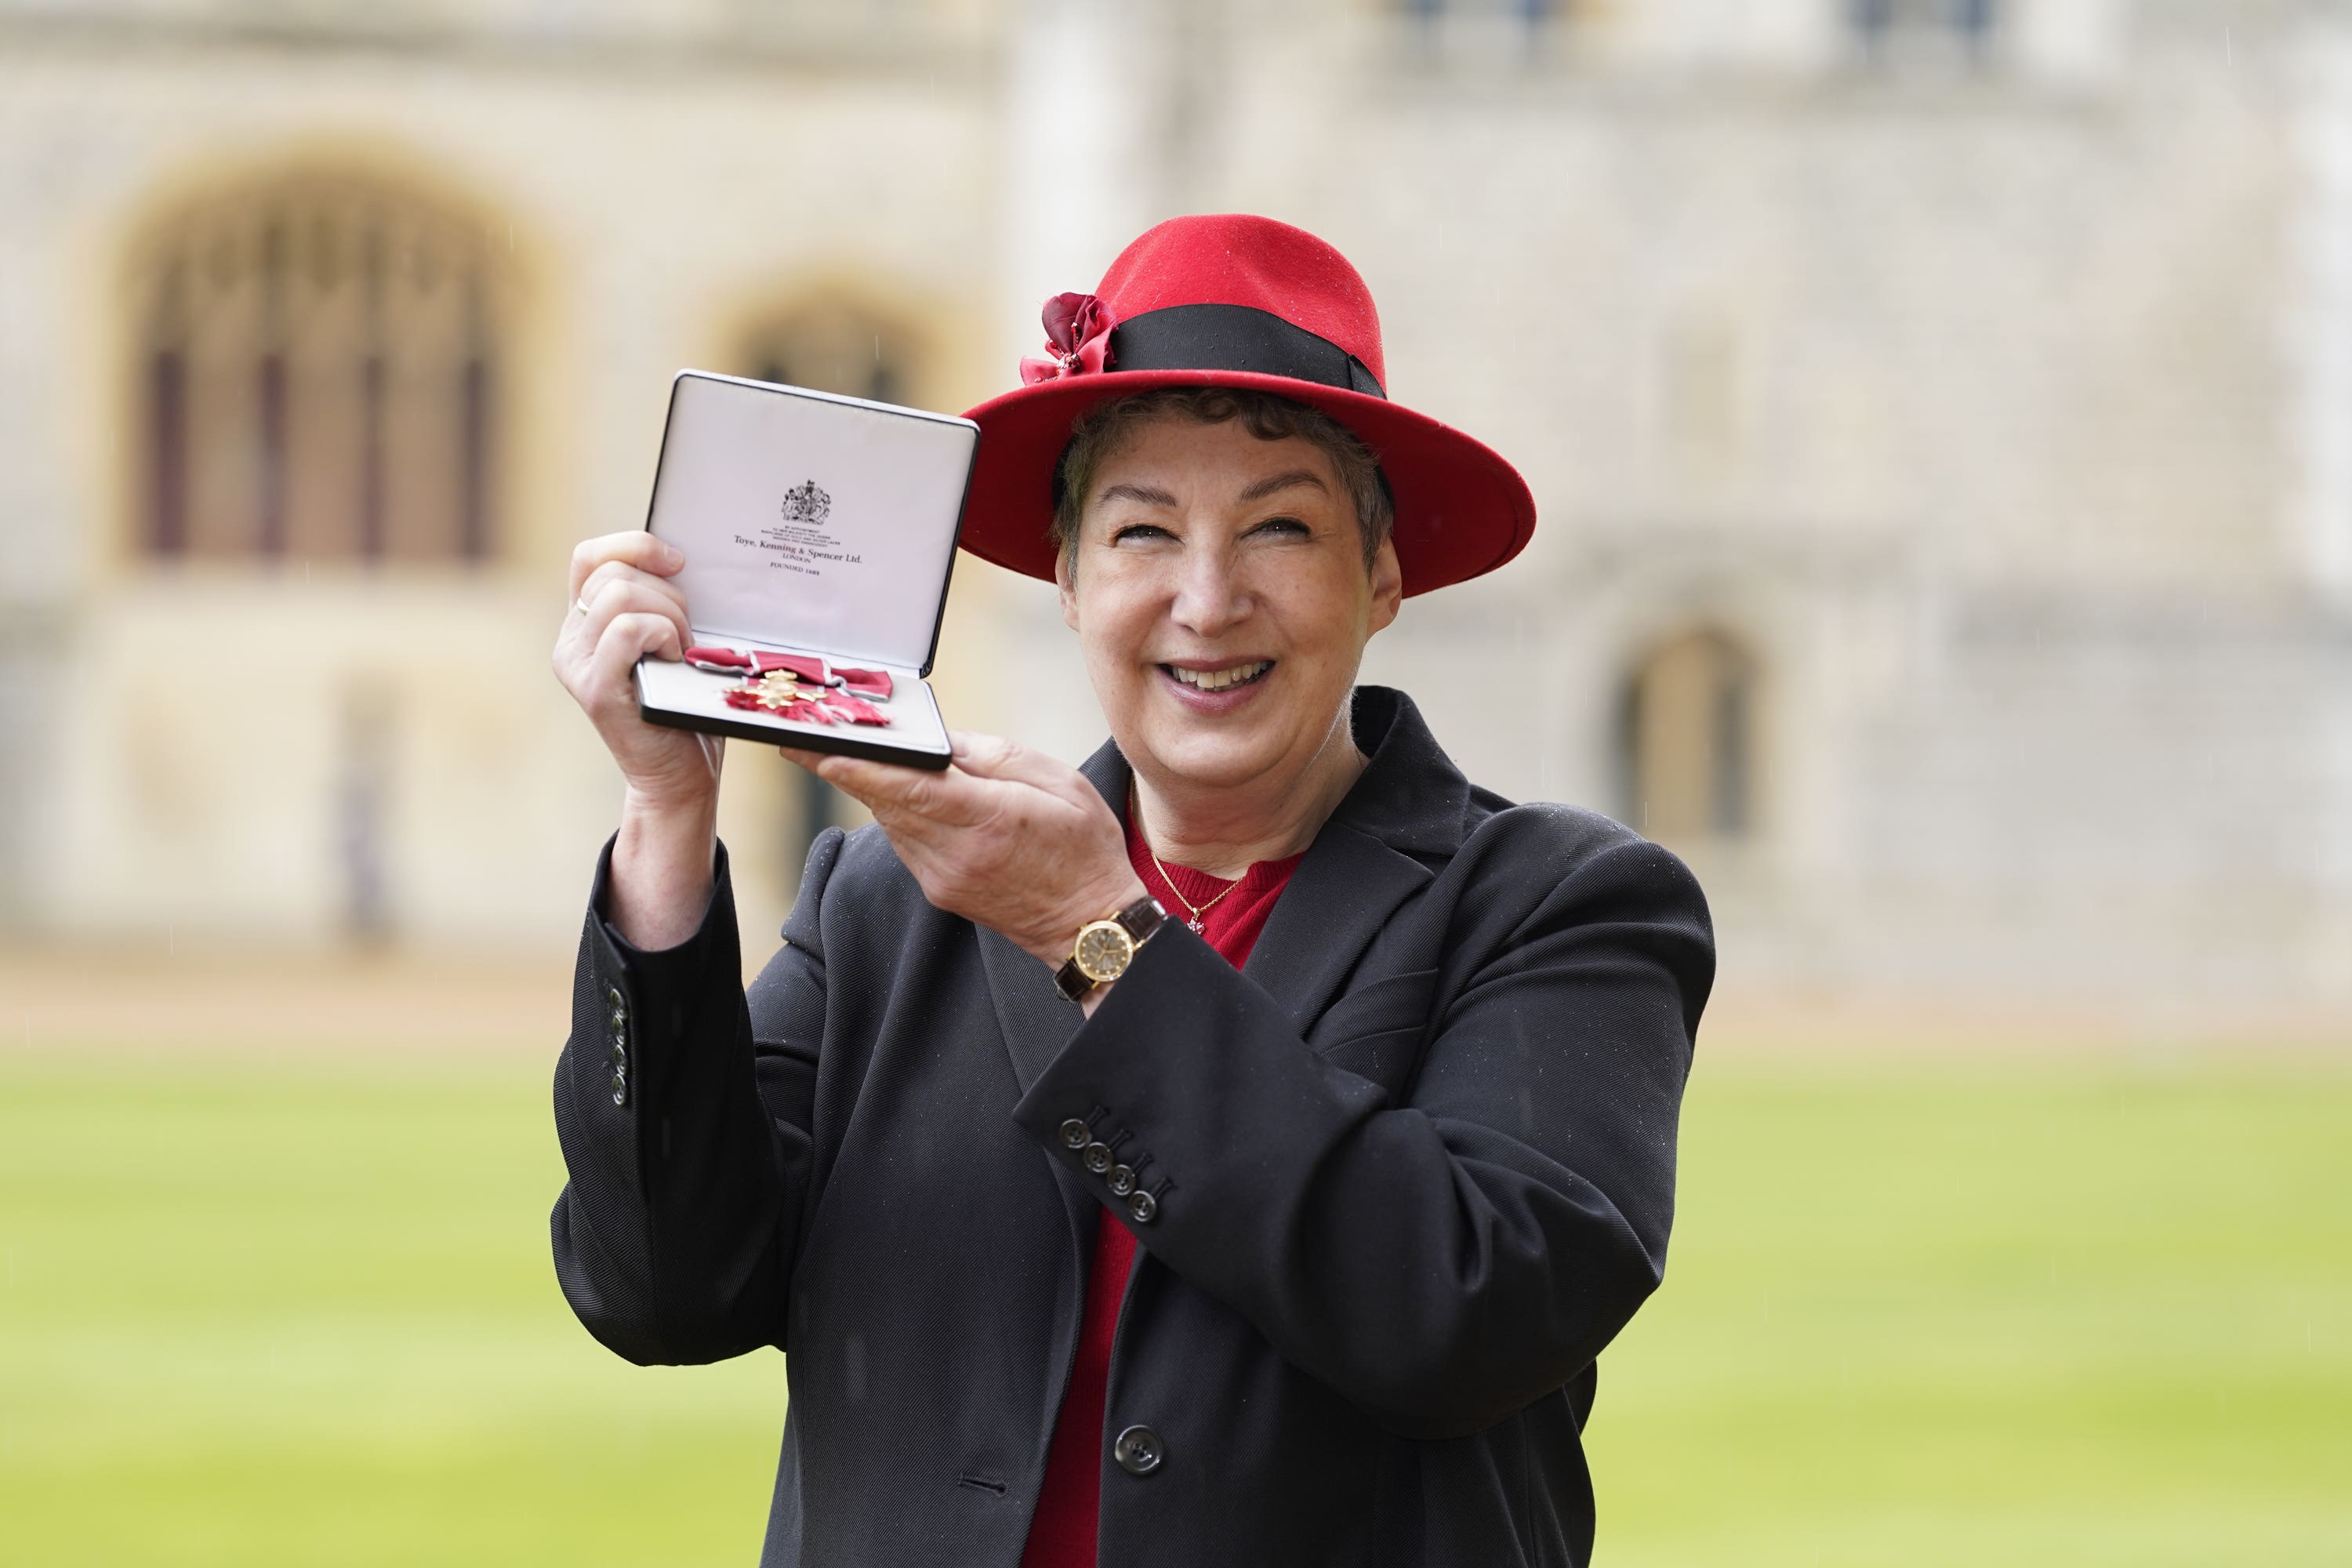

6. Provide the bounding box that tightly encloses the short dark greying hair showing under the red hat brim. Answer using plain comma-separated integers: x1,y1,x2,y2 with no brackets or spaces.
1054,386,1397,572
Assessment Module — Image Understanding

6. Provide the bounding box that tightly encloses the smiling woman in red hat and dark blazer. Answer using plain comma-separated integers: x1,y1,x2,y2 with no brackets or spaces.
555,216,1712,1568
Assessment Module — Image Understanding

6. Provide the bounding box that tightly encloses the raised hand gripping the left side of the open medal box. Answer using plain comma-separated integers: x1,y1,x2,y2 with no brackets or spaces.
555,529,722,806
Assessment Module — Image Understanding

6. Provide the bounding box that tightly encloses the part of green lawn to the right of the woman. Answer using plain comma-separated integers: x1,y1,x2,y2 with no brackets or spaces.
1590,1060,2352,1568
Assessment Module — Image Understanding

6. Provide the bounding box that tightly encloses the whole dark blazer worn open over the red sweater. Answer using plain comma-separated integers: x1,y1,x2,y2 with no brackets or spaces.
555,687,1715,1568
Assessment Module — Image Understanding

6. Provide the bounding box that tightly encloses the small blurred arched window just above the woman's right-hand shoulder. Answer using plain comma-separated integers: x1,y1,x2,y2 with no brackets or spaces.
1618,630,1757,844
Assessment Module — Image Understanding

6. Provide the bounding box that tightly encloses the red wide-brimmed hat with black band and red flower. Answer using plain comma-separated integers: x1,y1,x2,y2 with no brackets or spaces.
960,214,1536,595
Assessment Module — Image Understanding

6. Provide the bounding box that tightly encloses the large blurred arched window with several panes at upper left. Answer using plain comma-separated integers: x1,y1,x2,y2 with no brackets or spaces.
132,174,501,562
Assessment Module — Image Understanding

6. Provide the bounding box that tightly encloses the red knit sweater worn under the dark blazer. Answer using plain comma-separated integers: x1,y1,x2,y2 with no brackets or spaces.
1021,820,1305,1568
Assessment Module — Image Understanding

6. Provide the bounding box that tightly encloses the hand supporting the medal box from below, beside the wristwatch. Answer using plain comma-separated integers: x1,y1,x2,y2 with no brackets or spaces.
783,731,1143,968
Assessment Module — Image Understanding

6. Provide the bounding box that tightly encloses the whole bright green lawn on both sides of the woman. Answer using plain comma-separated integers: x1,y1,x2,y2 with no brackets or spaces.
0,1051,2352,1568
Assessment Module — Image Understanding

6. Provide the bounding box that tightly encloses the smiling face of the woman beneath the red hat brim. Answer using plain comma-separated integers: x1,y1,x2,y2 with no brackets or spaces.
1058,414,1402,801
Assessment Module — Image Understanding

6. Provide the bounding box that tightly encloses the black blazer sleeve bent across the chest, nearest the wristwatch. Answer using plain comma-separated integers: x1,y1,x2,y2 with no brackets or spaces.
1016,808,1715,1439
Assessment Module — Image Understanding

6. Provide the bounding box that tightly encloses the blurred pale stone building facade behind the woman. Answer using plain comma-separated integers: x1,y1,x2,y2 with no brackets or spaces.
0,0,2352,1020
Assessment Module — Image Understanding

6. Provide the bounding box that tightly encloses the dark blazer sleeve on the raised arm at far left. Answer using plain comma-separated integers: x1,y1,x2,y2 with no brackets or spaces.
553,829,842,1366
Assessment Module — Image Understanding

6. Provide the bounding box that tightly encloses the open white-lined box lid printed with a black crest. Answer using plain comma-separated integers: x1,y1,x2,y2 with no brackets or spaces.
644,369,981,675
